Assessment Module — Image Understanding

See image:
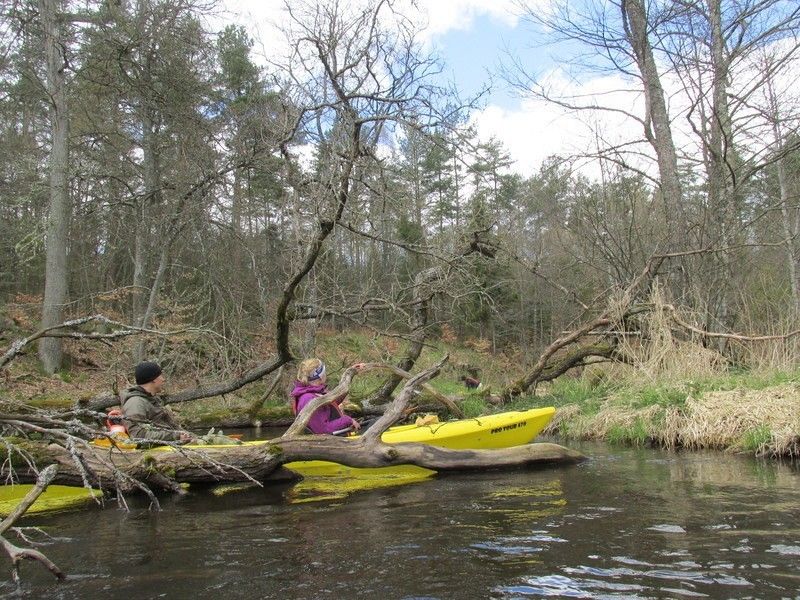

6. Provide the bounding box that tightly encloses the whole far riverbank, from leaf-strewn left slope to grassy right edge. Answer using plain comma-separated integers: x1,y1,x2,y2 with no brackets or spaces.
2,324,800,457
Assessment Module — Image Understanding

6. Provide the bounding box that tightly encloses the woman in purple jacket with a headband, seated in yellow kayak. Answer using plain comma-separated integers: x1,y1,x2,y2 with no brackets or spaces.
292,358,361,435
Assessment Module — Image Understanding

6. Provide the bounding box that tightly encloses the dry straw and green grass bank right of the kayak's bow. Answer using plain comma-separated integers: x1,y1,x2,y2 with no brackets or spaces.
524,374,800,457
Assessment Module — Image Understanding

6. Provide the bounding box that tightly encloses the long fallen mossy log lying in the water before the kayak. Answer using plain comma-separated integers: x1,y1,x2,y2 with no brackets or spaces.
10,435,584,491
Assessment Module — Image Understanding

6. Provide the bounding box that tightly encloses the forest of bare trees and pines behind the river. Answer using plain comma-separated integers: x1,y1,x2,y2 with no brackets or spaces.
0,0,800,453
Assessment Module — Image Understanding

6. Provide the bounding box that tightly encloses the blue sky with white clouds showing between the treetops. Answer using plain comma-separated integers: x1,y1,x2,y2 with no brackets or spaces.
220,0,800,177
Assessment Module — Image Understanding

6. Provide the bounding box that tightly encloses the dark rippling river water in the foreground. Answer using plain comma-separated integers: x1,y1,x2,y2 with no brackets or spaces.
0,436,800,600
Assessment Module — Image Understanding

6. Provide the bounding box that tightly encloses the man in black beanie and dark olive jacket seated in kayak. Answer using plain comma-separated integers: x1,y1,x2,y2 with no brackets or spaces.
121,361,197,443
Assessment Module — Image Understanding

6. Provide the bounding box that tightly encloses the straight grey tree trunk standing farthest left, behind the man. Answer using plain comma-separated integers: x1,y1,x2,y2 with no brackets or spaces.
39,0,71,374
